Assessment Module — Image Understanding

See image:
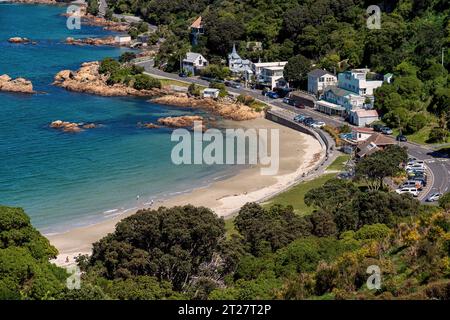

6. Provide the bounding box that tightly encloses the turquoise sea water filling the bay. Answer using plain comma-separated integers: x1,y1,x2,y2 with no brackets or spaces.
0,3,239,232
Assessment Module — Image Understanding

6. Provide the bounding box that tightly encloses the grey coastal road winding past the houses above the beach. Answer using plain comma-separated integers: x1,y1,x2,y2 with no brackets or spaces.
136,60,450,200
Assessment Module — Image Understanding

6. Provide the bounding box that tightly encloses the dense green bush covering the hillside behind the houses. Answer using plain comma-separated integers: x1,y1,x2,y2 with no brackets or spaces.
103,0,450,143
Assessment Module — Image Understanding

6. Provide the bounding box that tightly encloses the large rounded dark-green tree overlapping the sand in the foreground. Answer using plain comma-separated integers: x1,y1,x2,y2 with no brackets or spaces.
88,205,225,290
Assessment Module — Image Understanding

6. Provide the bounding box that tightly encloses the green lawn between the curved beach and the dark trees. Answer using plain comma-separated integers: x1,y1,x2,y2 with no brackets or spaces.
264,173,336,214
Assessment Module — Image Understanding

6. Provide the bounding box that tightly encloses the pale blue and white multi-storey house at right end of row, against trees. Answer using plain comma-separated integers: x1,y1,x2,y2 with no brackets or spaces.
338,69,383,96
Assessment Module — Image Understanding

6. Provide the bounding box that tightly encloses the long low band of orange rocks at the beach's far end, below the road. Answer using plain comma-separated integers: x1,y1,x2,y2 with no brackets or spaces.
151,94,262,121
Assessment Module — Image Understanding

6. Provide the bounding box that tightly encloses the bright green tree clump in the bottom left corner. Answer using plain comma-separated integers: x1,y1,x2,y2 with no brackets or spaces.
0,206,68,300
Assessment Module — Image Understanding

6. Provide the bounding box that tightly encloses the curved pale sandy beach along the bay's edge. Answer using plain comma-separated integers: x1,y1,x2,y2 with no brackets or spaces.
47,119,325,265
